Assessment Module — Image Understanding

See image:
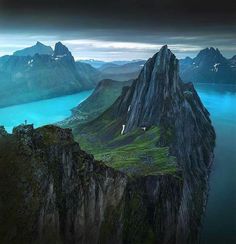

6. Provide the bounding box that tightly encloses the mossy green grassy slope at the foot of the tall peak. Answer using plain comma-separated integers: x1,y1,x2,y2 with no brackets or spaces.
77,126,177,175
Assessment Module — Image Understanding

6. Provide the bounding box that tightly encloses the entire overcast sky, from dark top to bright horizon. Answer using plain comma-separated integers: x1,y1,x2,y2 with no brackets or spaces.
0,0,236,61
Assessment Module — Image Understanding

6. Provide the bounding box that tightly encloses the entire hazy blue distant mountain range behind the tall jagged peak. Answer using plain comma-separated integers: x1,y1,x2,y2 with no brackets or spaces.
0,42,236,107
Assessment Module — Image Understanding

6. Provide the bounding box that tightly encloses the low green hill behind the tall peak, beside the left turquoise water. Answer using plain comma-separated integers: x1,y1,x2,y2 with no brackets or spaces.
57,80,132,128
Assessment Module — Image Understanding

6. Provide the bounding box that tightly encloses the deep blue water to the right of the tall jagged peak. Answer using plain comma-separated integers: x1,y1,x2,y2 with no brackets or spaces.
196,84,236,244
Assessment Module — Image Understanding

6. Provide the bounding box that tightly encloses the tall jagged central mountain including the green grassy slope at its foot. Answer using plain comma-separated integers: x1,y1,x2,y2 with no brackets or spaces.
74,46,215,244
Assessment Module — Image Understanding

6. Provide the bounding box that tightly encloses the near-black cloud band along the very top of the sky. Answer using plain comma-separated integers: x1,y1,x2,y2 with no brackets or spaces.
0,0,236,28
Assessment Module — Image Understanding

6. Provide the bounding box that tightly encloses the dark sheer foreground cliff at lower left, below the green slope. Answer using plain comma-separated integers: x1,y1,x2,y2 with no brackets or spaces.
0,125,182,243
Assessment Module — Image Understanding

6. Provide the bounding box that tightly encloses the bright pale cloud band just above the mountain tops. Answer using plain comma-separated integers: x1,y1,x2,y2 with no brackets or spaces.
0,29,236,61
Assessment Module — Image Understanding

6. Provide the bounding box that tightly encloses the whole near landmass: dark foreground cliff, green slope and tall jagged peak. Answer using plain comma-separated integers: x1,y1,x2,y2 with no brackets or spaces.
0,46,215,244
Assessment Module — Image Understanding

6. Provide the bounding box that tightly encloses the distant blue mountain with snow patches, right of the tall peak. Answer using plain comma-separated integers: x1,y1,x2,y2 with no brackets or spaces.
180,47,236,83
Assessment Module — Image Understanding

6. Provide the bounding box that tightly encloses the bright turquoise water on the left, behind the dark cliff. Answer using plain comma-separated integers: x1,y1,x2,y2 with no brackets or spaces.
0,90,92,132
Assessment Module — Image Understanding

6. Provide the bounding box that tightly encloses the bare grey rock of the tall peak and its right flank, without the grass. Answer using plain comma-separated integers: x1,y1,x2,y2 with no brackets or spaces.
76,46,215,243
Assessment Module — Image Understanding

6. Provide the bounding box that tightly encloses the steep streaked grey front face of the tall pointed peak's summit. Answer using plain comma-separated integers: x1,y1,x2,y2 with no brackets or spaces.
115,45,182,133
